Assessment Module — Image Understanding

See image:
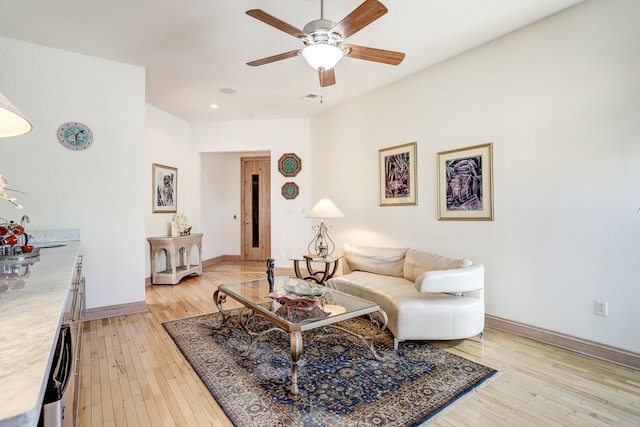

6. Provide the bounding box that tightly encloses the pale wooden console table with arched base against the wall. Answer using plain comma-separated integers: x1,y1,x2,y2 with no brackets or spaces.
147,233,202,285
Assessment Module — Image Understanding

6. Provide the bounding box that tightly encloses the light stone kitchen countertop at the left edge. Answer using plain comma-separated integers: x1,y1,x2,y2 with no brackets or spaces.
0,240,80,427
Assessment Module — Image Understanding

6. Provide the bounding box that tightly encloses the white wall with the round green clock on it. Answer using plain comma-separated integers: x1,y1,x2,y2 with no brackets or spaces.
0,37,150,308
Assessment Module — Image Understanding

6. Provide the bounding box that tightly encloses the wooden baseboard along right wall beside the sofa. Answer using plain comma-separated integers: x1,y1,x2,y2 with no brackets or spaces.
485,315,640,369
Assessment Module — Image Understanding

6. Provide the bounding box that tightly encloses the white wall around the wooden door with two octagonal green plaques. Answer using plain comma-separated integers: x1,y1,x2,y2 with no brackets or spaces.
191,119,315,267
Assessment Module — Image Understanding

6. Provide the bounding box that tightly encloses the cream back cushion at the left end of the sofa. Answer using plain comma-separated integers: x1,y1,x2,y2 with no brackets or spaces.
342,243,407,277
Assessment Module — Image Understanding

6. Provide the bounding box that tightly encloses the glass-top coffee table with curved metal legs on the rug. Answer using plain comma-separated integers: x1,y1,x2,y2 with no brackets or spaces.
213,276,388,396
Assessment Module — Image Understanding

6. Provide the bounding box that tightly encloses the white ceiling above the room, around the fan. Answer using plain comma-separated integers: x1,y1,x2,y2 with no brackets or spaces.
0,0,582,123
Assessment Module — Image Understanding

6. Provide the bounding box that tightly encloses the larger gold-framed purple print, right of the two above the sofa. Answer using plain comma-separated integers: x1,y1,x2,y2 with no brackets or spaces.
438,143,493,221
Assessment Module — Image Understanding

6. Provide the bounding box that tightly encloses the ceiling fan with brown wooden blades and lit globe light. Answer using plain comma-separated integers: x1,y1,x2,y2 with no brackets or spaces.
247,0,404,87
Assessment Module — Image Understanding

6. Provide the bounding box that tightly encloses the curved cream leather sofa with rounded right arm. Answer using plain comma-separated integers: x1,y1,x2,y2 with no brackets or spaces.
327,244,484,348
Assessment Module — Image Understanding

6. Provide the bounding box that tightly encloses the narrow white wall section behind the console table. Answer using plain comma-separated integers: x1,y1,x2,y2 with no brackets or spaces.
143,104,192,277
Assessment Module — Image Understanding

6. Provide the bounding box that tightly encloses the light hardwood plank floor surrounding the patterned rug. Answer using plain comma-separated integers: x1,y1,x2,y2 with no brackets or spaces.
79,262,640,427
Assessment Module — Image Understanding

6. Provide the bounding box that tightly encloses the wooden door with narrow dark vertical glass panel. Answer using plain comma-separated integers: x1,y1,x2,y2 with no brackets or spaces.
241,157,271,261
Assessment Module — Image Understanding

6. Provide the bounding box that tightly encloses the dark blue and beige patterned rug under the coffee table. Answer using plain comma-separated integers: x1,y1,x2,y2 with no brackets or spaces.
163,311,497,427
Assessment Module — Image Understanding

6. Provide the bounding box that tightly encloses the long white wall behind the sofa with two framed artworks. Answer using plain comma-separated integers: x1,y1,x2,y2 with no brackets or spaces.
311,0,640,352
